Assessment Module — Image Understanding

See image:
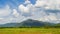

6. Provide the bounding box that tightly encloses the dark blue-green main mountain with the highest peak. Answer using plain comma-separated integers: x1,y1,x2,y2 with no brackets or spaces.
22,19,52,27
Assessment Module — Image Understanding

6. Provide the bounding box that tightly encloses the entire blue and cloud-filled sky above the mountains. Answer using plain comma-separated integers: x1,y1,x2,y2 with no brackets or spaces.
0,0,60,24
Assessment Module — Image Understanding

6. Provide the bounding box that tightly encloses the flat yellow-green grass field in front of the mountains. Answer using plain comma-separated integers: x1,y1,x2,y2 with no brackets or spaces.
0,28,60,34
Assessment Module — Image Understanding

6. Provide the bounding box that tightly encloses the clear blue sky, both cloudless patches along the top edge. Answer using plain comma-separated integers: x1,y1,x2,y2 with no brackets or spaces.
0,0,36,8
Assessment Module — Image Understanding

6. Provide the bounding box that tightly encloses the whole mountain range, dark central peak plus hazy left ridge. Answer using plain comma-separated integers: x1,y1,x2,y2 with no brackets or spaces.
0,19,52,27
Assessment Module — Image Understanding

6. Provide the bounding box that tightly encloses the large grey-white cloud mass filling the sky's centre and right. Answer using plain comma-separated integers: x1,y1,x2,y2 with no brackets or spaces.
18,0,60,23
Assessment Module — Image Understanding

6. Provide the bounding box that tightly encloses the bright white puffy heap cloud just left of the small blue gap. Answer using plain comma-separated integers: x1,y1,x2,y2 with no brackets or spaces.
18,0,33,13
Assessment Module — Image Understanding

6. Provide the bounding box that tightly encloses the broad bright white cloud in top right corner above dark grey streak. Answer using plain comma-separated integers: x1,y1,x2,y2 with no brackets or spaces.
35,0,60,10
